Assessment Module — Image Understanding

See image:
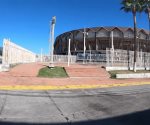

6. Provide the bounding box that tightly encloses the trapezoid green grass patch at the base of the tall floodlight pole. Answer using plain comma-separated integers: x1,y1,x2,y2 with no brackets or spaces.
38,67,68,78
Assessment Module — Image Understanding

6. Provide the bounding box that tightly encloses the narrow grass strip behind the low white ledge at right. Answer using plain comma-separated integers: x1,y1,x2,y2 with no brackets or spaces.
108,70,150,79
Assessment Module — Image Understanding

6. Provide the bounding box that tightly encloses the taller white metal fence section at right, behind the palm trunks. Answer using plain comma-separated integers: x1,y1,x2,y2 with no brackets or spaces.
106,49,150,69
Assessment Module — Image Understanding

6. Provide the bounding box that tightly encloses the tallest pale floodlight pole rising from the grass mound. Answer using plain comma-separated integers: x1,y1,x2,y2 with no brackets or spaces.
49,16,56,67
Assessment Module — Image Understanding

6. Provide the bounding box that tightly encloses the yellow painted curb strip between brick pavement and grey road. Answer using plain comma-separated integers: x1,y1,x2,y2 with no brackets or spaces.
0,82,150,90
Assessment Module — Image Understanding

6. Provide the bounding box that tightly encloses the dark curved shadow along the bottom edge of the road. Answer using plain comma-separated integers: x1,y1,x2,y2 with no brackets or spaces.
0,110,150,125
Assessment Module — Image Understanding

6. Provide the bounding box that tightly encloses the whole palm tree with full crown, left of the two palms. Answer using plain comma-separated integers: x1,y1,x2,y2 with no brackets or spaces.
121,0,142,72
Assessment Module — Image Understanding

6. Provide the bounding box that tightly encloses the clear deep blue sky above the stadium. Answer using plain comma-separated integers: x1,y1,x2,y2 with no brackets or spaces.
0,0,148,54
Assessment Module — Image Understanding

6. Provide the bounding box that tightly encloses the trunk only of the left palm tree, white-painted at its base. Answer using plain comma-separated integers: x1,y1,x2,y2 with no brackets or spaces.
133,12,137,72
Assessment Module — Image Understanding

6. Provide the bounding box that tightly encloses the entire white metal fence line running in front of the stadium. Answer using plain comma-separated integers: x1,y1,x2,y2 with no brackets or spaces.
37,49,150,69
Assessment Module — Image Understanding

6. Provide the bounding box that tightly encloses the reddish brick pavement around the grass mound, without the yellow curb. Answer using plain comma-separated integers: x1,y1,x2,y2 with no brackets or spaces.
0,63,150,86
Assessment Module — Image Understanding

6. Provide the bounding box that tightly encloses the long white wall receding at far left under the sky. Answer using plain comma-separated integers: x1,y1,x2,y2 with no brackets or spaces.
2,39,36,65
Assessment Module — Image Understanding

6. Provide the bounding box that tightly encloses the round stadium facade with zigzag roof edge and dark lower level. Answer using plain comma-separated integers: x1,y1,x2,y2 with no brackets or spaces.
54,27,150,55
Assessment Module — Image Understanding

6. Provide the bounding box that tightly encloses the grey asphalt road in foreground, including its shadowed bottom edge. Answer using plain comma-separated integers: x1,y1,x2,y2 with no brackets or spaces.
0,85,150,125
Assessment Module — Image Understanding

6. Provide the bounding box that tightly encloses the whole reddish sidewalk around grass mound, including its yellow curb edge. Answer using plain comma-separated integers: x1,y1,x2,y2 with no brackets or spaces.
0,63,150,90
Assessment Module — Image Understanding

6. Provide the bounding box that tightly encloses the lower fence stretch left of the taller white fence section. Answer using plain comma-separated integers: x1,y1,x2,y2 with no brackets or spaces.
36,50,106,65
